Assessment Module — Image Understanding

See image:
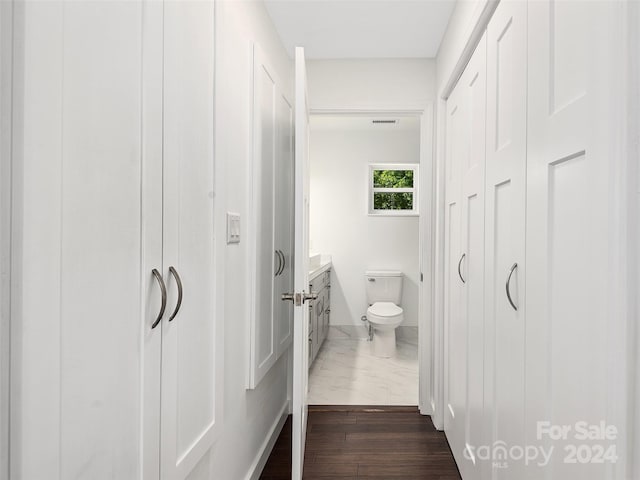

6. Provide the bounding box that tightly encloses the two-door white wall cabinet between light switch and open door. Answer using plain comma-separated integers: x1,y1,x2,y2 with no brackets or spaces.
247,44,294,388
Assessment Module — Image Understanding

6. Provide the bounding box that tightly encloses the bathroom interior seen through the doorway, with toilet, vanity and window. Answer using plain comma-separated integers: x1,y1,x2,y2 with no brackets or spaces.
308,112,421,405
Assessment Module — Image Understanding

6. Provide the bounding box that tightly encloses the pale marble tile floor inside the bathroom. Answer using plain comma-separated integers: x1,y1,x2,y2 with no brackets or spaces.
308,326,418,405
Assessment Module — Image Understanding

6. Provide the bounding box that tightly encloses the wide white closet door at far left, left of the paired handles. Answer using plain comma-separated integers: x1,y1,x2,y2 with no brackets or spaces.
11,2,162,480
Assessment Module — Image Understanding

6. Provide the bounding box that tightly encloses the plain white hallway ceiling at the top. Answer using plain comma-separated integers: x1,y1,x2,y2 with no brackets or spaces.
264,0,455,59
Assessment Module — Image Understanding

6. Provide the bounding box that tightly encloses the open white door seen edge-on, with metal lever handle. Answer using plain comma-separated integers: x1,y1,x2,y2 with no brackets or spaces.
283,47,314,480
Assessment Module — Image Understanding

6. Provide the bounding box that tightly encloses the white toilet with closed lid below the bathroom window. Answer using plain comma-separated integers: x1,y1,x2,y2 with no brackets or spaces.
365,270,404,357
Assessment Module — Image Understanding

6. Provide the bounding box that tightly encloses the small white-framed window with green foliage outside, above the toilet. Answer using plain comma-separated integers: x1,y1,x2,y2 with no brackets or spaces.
369,164,419,216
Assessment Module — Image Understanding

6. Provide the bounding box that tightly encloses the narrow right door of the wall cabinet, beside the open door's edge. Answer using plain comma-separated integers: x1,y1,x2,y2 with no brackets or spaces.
273,94,293,357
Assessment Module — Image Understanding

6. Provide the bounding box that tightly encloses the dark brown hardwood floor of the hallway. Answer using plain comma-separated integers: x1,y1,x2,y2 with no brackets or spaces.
260,406,460,480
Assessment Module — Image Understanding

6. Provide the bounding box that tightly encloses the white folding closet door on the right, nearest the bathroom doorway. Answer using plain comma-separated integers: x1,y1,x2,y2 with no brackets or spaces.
445,33,486,479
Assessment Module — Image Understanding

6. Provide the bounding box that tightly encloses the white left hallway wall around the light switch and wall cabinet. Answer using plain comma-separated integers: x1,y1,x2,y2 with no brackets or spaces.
211,1,293,480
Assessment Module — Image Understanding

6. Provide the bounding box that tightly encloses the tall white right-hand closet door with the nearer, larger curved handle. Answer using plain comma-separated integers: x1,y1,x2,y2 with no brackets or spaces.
484,1,527,480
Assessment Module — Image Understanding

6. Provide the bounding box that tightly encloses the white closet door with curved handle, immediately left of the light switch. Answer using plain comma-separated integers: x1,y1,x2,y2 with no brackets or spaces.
161,1,219,480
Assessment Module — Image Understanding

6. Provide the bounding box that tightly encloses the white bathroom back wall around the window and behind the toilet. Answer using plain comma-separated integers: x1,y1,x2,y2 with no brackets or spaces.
310,119,420,325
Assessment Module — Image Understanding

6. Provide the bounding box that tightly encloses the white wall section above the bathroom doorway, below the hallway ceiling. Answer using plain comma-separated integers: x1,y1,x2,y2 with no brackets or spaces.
307,58,436,110
